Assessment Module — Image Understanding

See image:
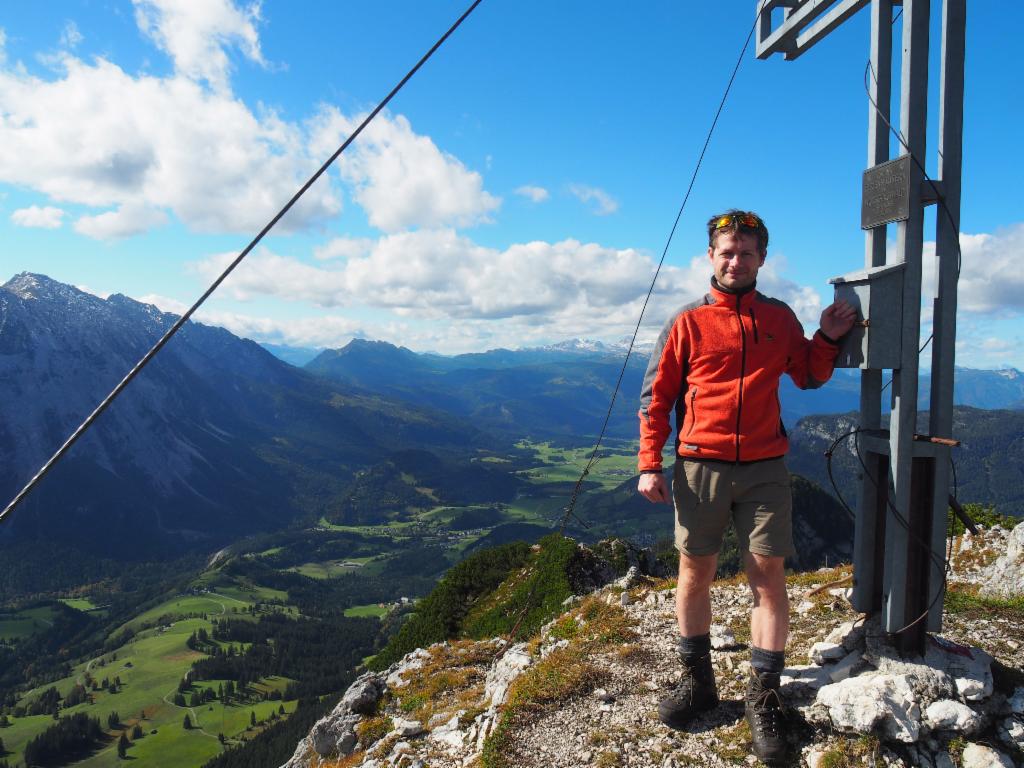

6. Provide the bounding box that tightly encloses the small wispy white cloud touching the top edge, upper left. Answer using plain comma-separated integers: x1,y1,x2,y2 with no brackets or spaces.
133,0,264,91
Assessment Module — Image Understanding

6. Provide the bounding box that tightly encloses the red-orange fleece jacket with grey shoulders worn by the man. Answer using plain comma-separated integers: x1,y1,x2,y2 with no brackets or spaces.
639,285,839,471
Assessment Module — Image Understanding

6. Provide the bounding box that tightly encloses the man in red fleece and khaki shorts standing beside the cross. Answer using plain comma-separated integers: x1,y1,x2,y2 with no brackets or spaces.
639,210,856,762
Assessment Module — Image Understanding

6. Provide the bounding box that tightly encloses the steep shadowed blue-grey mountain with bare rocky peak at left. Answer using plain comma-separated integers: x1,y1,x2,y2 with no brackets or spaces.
0,273,481,556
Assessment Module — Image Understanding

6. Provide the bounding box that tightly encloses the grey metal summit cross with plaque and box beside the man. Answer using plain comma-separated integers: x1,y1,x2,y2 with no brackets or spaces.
757,0,967,653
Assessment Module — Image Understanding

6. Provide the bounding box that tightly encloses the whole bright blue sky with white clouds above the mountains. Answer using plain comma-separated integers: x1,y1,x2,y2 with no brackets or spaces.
0,0,1024,368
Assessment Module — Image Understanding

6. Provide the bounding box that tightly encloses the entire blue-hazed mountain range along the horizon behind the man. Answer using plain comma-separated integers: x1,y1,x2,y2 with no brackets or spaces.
0,272,1024,557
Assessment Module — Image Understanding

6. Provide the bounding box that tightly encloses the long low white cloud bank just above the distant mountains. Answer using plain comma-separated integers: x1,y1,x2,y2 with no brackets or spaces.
196,229,820,338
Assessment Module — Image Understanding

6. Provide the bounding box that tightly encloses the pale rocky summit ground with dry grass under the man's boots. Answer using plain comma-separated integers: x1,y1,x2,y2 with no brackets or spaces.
285,524,1024,768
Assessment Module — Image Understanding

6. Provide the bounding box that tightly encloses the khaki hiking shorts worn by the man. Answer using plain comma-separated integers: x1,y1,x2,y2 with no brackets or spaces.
672,457,795,557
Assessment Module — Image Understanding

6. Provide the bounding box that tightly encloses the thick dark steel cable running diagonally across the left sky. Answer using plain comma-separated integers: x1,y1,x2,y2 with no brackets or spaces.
0,0,482,522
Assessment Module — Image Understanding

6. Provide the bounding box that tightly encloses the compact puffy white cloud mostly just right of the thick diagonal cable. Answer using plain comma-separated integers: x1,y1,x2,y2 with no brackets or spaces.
312,106,501,232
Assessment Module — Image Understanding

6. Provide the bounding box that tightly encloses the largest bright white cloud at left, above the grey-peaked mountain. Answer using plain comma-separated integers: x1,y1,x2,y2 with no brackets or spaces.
0,56,341,232
